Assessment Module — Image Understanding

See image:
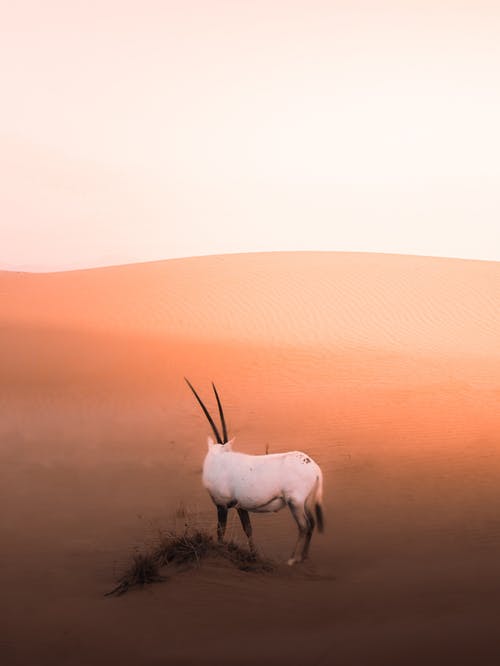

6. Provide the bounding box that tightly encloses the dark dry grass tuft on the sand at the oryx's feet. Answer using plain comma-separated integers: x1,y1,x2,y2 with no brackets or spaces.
105,529,274,596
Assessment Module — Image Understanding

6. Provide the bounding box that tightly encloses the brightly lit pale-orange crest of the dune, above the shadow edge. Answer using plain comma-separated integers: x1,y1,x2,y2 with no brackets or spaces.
0,252,500,356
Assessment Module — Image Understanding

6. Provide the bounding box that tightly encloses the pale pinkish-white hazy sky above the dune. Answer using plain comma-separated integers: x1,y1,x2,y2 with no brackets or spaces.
0,0,500,270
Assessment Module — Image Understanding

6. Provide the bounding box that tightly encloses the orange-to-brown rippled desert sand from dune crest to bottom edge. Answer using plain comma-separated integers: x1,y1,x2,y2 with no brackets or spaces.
0,253,500,666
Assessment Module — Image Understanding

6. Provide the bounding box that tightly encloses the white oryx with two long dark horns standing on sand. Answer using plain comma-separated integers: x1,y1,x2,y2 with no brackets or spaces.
185,378,323,565
